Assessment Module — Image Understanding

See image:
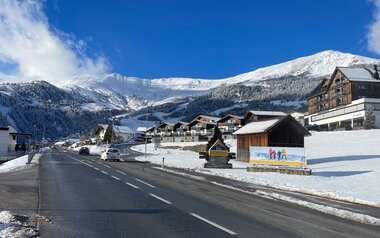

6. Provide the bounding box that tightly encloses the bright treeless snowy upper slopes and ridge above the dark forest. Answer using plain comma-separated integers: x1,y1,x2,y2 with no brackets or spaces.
51,50,380,109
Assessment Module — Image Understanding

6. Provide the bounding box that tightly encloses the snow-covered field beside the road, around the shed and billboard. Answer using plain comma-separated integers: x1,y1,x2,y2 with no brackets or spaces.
133,130,380,206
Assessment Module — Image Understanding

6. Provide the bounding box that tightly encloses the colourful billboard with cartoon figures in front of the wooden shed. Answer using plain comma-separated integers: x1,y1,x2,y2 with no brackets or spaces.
249,146,307,166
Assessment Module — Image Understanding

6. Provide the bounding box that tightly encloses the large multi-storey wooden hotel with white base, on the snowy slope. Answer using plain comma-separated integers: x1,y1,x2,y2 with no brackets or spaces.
305,65,380,130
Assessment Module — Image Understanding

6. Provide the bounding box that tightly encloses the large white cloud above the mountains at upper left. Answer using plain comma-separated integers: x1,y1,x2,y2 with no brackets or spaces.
0,0,109,82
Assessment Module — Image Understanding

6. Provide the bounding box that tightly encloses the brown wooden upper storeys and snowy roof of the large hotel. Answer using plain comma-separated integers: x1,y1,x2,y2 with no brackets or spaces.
307,65,380,115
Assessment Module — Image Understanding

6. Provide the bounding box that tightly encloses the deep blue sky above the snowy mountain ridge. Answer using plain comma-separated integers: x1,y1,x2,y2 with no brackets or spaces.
0,0,380,81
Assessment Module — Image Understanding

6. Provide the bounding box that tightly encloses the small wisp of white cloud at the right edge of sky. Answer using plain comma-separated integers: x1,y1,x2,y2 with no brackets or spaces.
367,0,380,54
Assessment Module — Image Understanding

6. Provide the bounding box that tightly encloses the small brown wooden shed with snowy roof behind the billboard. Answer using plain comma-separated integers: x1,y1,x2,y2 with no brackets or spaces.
234,115,311,162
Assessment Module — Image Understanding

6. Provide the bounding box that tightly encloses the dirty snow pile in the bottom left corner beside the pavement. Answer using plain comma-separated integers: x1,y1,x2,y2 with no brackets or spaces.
0,211,37,238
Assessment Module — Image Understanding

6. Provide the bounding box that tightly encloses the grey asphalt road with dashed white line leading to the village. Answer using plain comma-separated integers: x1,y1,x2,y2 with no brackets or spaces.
40,152,380,237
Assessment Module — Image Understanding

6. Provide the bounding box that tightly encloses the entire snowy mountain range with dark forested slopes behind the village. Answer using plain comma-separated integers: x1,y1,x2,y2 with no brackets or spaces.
0,51,380,138
